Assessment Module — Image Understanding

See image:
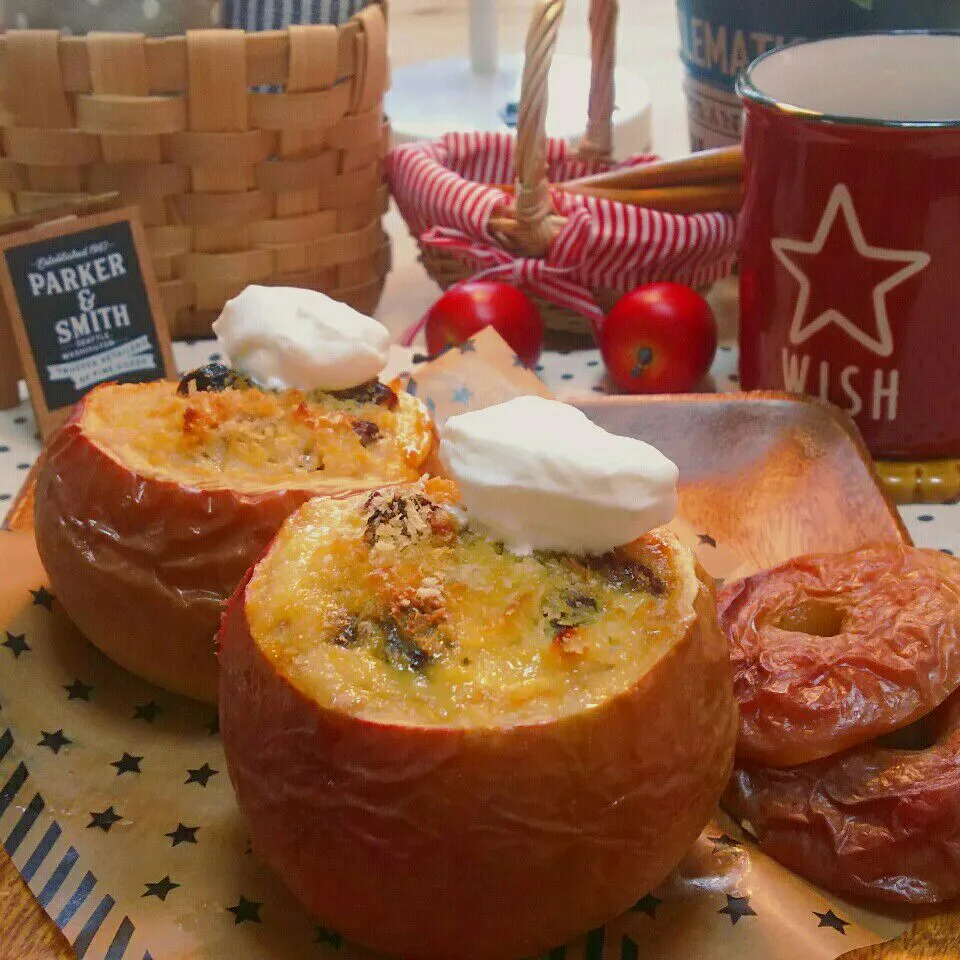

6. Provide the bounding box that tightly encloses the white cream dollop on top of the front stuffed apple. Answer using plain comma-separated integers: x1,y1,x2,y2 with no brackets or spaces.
439,397,678,553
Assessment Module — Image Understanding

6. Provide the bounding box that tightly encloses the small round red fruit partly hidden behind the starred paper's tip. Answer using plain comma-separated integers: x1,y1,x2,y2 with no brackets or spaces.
425,280,543,367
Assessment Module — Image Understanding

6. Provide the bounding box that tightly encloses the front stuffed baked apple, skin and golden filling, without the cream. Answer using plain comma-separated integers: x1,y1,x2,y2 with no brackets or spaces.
219,398,736,960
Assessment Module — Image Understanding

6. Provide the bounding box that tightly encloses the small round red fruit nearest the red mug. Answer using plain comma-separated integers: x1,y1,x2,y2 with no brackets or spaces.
599,283,717,393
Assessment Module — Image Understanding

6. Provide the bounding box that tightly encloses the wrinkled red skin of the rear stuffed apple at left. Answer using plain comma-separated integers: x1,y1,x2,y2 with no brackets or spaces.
34,393,434,703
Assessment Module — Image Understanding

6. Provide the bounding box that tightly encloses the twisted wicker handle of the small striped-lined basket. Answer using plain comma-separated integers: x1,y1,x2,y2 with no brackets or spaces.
516,0,618,255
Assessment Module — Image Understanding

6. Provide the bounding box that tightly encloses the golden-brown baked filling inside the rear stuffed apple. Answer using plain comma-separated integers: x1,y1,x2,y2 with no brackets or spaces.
84,381,431,491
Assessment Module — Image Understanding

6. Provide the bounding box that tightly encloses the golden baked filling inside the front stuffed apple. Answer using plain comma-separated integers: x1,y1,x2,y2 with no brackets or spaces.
246,481,692,726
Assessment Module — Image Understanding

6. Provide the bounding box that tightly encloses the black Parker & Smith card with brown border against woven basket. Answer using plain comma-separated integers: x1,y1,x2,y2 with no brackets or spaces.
5,221,164,410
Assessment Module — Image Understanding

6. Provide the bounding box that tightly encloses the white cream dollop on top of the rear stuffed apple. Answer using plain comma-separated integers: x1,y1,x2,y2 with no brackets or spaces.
213,286,390,390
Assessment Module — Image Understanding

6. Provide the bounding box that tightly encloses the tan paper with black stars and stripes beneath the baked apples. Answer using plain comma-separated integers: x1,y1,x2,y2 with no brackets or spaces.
0,333,916,960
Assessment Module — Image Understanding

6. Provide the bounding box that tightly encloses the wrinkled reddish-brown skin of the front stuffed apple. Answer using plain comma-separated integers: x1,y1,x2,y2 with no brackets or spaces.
219,521,737,960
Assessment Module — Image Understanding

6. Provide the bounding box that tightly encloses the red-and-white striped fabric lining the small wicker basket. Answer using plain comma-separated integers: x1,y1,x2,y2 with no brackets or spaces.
386,133,736,341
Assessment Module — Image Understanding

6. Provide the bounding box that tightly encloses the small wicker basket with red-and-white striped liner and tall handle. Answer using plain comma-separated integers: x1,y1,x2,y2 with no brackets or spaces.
386,0,736,347
